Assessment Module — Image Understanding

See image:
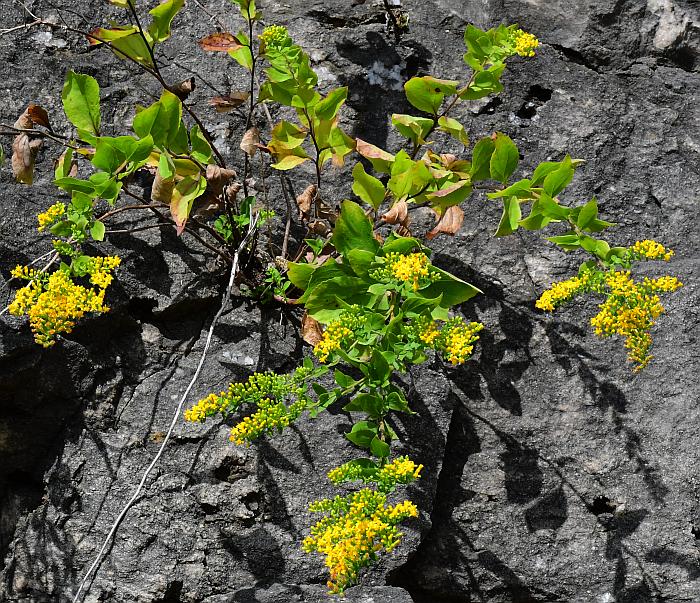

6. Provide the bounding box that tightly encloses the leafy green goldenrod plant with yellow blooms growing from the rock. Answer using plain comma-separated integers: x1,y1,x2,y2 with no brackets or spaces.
0,0,681,593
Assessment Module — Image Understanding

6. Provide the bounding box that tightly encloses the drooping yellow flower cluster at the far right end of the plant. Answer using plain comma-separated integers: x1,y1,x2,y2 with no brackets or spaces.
591,272,683,371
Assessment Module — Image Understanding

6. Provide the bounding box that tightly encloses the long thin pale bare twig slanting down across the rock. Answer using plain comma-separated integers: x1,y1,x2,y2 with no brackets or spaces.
73,219,257,603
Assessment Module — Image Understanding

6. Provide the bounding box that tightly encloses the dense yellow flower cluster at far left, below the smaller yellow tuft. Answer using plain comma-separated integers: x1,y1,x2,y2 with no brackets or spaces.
9,270,109,347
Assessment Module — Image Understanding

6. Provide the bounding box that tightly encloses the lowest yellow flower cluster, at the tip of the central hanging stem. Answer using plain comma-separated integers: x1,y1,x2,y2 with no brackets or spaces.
303,488,418,593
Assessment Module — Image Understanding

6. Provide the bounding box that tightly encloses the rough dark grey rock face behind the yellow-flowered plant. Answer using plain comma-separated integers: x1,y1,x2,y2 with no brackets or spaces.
0,0,700,603
